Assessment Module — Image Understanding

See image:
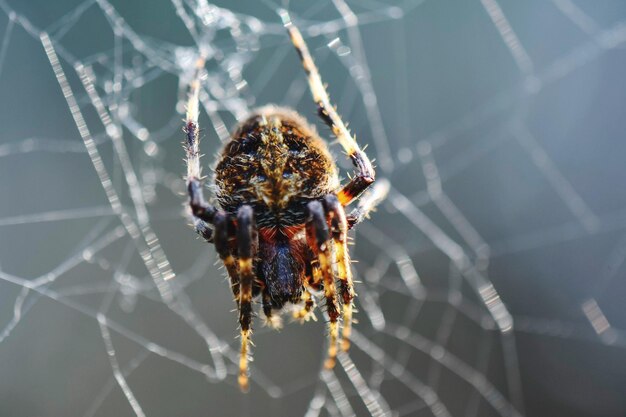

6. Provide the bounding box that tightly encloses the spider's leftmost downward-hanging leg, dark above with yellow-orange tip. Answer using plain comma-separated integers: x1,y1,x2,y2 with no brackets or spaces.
237,206,258,392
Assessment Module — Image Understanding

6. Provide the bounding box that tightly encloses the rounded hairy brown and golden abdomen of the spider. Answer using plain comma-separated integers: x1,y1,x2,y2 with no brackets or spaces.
214,106,339,221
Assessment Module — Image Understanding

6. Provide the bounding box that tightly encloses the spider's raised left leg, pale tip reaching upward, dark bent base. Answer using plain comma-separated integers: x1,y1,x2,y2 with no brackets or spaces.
184,55,217,228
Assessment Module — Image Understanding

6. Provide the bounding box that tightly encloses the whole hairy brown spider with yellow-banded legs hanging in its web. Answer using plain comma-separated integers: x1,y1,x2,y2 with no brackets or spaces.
184,13,388,392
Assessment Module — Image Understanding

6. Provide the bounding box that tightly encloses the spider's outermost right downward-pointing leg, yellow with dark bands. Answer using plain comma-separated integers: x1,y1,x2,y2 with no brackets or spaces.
324,194,356,352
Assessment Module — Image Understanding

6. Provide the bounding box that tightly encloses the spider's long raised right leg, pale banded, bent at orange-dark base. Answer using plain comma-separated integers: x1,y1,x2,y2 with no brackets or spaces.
282,17,375,206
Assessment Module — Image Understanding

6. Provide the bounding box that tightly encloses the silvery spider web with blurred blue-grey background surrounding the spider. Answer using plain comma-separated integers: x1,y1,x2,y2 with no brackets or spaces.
0,0,626,417
